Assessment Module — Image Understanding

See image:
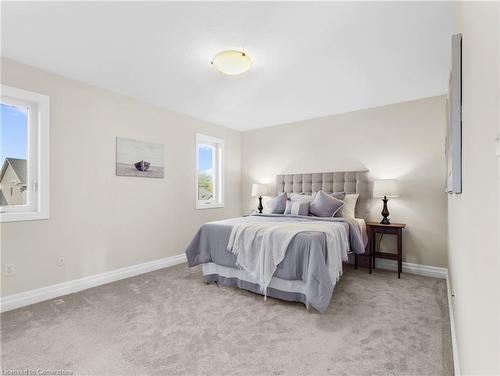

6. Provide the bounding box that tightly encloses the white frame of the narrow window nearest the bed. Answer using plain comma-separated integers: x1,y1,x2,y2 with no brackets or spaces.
195,133,224,209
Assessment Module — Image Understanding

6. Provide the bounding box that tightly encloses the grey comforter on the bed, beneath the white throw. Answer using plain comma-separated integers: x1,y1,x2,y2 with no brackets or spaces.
186,214,365,312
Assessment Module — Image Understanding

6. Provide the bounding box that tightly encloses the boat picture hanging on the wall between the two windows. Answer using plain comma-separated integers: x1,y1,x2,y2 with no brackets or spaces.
116,137,164,179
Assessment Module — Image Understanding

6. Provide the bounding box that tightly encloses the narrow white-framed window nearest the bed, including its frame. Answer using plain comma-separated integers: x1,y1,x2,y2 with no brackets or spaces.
196,134,224,209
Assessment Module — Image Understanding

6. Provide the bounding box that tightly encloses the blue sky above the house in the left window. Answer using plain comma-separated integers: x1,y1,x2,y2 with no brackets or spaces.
0,103,28,167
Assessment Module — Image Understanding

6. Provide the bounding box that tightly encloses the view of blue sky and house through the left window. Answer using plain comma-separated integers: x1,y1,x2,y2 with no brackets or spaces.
0,103,28,206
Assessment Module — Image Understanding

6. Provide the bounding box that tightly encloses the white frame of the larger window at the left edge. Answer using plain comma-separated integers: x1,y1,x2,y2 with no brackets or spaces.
0,85,50,222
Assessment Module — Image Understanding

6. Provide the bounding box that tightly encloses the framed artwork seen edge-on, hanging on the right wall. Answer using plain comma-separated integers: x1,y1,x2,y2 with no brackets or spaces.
445,34,462,193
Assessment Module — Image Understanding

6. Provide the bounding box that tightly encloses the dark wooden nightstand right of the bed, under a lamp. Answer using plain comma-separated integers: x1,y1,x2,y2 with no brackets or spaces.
366,222,406,278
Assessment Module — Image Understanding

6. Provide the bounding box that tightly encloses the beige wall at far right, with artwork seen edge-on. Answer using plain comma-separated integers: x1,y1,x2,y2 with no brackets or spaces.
448,2,500,375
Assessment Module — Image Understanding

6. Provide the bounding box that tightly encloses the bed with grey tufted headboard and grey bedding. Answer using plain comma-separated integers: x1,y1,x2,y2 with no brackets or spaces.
186,171,370,313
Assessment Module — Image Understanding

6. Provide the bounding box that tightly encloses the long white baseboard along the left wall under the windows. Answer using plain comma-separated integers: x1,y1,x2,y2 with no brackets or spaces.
0,253,187,312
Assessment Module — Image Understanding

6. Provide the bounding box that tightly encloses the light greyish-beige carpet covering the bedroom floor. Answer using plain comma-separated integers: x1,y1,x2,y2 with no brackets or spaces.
1,265,453,375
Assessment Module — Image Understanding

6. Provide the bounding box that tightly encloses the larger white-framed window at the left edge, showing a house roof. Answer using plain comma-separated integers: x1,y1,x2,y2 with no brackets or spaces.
0,85,49,222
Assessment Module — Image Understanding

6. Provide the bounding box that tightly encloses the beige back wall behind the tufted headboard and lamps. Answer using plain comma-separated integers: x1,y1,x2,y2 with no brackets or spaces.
242,97,447,267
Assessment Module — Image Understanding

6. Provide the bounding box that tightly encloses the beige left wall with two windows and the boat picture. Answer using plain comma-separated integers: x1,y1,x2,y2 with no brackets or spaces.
1,60,241,296
